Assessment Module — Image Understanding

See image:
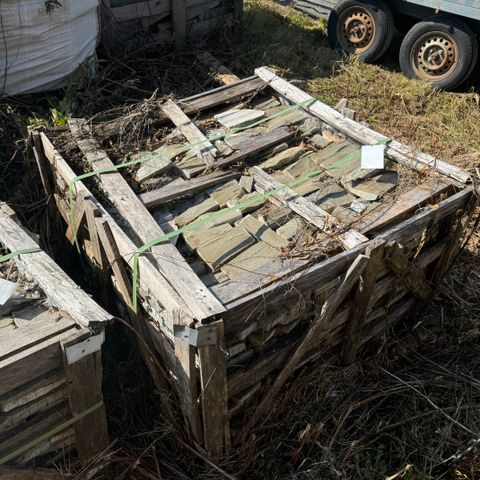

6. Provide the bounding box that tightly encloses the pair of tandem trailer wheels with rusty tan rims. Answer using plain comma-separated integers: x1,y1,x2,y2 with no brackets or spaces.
328,0,478,90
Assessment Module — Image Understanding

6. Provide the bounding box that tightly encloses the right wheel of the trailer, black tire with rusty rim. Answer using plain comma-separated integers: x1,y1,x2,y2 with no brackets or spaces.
399,16,478,90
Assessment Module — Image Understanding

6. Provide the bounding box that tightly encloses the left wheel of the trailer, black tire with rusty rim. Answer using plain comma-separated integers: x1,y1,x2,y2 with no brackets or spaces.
328,0,394,62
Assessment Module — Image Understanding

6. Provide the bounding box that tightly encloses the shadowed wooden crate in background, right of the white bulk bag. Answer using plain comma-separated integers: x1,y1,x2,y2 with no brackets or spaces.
102,0,243,43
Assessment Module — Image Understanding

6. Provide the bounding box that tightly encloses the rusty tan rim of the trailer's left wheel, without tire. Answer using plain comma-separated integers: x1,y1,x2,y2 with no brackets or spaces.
337,5,375,53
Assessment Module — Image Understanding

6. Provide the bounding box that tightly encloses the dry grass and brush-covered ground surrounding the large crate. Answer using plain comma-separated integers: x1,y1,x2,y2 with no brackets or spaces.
0,0,480,480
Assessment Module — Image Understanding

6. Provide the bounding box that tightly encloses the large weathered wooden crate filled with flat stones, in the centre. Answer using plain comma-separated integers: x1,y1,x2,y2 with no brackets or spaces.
35,68,476,454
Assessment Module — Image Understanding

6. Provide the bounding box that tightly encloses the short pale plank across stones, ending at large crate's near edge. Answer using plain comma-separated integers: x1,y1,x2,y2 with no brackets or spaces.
252,167,368,249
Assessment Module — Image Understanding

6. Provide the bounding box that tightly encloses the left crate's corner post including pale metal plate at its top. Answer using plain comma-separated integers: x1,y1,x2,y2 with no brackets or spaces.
62,330,108,464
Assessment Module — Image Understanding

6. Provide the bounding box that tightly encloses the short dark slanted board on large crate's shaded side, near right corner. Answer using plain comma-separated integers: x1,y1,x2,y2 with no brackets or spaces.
385,242,431,300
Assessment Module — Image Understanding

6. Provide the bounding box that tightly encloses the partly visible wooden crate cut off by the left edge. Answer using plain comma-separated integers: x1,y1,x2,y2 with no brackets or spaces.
0,203,111,470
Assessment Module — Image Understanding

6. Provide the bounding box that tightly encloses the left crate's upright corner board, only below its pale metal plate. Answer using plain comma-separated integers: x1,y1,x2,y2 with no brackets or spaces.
62,334,108,465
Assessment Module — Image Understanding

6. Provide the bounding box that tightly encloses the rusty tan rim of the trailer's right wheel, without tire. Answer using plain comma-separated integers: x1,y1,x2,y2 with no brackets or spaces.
410,32,458,82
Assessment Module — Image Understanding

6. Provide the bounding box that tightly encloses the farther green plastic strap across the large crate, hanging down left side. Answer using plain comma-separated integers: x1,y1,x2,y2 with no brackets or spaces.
68,98,316,249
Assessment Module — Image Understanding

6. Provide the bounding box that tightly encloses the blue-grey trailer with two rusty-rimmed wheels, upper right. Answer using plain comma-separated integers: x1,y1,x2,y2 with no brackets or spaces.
291,0,480,90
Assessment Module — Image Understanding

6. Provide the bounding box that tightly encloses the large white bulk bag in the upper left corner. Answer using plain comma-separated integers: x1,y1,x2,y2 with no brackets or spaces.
0,0,99,96
